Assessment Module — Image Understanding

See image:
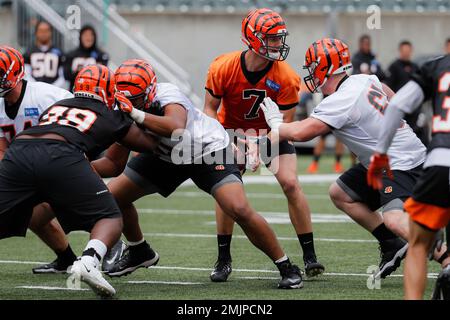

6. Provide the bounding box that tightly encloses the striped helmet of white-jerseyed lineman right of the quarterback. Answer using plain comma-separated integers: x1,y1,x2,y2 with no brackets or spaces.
303,38,352,92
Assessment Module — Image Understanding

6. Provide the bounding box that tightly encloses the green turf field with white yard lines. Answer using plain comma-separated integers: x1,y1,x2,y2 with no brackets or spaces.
0,156,439,300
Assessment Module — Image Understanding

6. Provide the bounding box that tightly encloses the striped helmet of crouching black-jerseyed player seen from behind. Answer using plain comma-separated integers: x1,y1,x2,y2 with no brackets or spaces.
73,64,116,109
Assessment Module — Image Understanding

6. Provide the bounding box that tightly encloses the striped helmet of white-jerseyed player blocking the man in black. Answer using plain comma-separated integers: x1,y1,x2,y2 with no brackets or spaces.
114,59,156,110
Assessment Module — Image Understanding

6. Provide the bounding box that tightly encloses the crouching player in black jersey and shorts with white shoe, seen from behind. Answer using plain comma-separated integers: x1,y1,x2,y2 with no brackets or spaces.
0,65,160,297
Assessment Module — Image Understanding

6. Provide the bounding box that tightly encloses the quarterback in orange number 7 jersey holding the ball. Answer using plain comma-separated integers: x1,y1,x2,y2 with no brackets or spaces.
204,8,325,282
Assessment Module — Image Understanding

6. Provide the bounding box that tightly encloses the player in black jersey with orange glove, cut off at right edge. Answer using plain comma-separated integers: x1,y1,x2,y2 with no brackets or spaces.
368,54,450,300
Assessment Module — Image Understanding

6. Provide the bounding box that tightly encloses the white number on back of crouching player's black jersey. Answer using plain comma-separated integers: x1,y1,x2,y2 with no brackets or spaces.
39,106,97,132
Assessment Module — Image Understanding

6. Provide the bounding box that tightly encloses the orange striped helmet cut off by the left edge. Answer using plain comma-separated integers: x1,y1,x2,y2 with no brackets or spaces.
0,46,25,97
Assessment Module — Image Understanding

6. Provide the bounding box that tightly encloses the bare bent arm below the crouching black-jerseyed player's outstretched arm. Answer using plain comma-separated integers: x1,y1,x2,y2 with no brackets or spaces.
91,143,130,178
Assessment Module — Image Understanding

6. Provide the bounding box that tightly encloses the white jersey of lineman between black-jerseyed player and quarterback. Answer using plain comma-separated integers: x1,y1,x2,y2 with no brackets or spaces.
151,83,230,164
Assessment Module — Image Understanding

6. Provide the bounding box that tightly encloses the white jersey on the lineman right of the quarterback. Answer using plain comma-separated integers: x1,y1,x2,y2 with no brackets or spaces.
311,74,426,171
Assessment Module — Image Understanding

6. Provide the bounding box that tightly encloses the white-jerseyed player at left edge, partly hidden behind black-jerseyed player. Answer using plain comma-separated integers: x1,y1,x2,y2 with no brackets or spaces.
0,46,76,273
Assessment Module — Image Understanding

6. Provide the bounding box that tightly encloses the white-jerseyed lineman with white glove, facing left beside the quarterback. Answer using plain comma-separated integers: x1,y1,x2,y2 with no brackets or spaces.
261,38,426,278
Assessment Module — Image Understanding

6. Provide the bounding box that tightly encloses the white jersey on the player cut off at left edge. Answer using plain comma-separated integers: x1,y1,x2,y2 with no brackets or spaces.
0,81,73,143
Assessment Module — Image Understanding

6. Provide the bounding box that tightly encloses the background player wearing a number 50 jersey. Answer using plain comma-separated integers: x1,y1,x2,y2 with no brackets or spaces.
24,21,67,88
